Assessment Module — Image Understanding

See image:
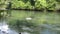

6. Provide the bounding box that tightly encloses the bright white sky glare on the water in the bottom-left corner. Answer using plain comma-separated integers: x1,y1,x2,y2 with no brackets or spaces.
0,19,18,34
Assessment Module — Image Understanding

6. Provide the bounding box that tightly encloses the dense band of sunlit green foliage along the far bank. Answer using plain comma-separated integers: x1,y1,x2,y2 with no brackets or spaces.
0,0,60,10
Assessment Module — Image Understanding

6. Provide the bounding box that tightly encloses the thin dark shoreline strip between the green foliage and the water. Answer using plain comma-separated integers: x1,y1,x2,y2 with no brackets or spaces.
0,8,60,12
